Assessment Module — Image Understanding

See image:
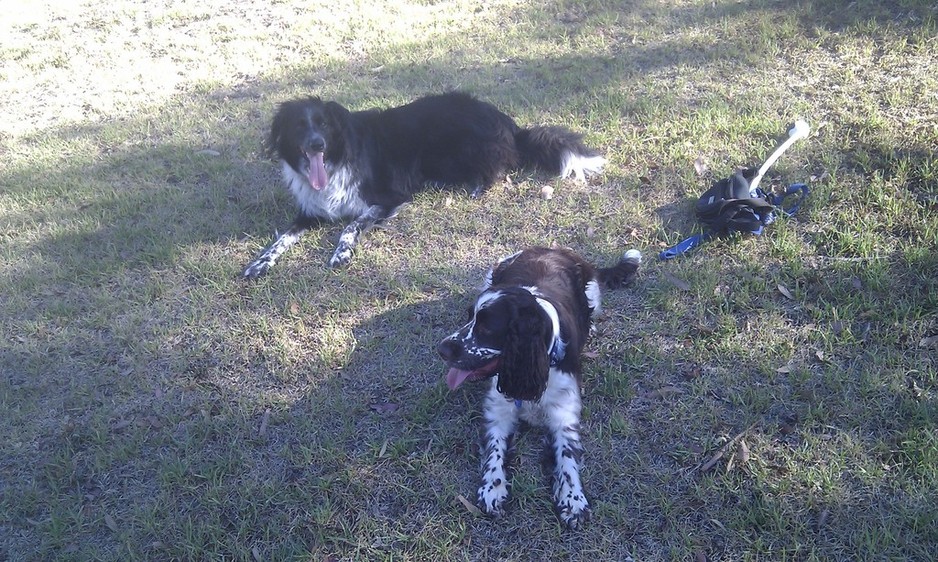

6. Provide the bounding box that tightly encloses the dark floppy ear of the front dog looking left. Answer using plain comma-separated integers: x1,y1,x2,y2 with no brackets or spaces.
498,298,553,400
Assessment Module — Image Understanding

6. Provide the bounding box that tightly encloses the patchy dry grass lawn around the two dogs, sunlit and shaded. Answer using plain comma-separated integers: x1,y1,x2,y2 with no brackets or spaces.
0,0,938,562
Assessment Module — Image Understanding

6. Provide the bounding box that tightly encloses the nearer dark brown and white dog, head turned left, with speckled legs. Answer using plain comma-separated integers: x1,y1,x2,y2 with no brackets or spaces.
437,244,641,529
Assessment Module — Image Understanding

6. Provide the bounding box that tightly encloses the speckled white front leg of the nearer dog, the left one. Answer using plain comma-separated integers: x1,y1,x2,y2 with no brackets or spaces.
477,382,518,516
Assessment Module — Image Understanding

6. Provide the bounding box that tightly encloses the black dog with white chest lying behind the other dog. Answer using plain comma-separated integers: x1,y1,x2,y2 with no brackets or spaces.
244,93,606,277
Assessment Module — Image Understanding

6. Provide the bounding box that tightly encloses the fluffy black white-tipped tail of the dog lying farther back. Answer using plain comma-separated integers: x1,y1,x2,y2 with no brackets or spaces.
515,126,606,181
